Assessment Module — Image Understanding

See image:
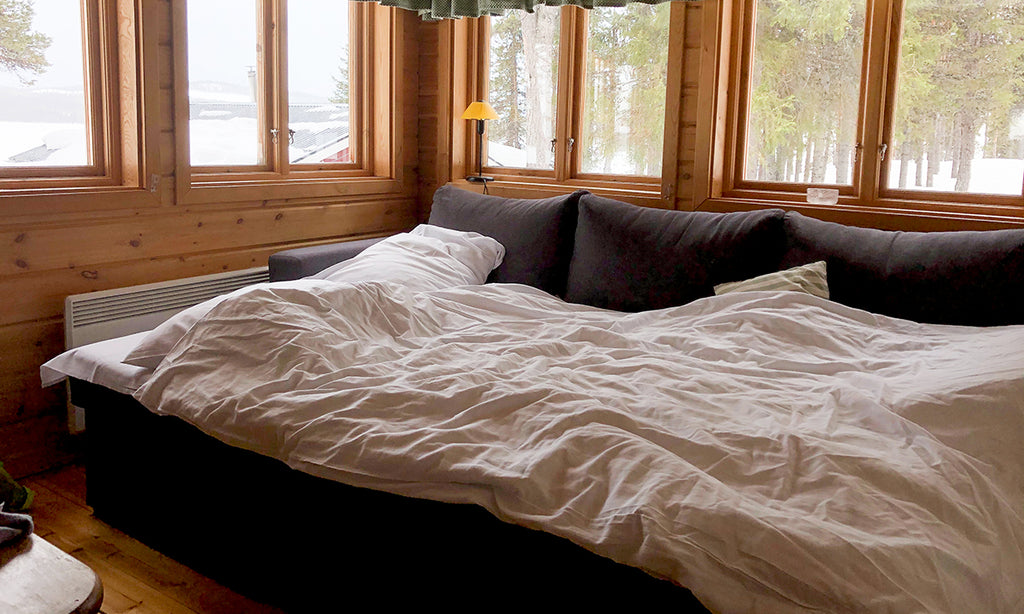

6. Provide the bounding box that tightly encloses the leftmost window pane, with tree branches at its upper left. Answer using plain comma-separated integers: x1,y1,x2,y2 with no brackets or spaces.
0,0,90,167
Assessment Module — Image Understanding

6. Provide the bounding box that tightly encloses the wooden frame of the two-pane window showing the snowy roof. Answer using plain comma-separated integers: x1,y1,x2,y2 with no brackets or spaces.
172,0,403,204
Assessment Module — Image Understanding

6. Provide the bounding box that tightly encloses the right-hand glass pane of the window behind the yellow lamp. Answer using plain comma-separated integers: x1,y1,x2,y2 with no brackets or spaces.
580,3,670,176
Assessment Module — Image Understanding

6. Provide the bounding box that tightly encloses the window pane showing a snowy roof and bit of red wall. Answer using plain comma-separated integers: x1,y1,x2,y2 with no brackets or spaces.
288,0,352,164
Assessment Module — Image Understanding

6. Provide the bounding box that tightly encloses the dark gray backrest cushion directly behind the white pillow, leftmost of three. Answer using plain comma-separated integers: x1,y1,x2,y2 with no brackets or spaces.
427,185,585,296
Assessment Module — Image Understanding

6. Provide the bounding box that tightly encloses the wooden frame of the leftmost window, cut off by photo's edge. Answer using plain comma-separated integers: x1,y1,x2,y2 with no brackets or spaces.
0,0,159,207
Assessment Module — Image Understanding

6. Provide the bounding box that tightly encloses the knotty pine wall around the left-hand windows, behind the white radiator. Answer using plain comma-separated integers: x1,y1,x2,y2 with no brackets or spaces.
0,0,420,476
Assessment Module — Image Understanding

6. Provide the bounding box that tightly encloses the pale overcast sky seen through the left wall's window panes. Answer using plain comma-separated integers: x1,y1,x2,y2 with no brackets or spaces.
0,0,348,98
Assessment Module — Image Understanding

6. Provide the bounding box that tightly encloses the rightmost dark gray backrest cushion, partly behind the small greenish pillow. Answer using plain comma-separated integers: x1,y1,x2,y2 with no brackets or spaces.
782,212,1024,326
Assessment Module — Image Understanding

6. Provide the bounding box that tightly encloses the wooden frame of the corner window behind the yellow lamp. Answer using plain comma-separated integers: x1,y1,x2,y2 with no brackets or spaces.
466,2,686,208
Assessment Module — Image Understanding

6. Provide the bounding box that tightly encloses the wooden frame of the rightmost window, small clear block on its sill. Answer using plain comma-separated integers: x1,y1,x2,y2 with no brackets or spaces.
694,0,1024,229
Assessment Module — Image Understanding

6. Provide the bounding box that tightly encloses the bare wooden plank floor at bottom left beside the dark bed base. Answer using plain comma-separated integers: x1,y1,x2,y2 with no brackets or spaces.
22,466,281,614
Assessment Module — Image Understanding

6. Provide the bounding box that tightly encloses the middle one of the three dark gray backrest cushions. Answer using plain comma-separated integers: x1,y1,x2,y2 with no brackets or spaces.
565,194,785,311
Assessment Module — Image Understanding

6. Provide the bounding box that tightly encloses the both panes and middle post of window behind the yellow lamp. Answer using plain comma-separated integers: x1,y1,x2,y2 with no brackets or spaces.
483,3,670,183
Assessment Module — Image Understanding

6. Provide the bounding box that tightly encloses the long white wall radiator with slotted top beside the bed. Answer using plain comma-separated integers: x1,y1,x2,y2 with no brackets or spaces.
65,266,269,433
